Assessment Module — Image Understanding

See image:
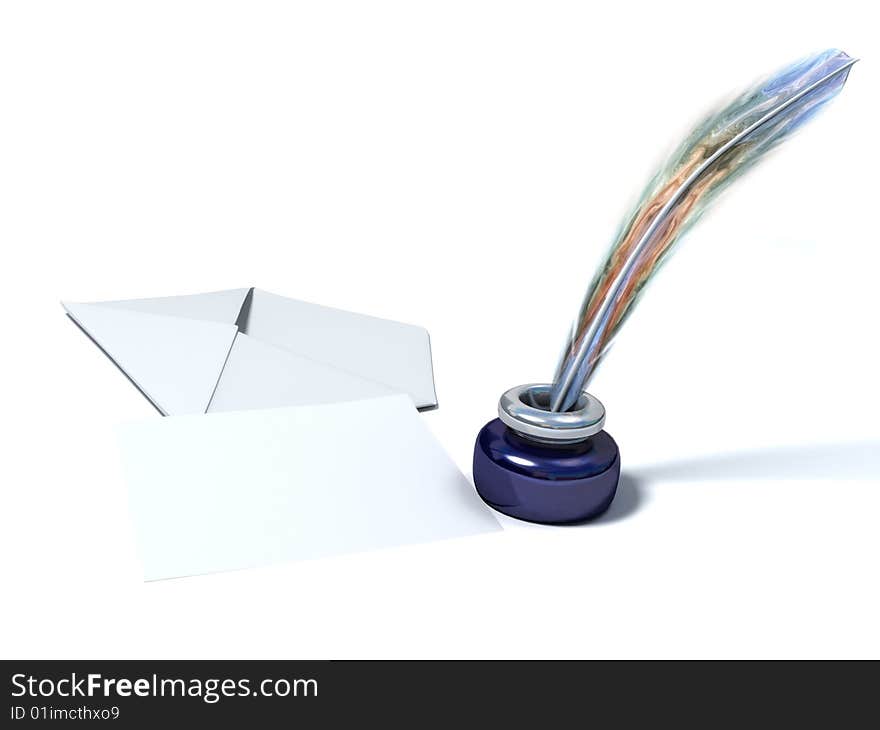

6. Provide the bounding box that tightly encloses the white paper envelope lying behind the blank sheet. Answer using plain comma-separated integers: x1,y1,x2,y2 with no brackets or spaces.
62,288,437,415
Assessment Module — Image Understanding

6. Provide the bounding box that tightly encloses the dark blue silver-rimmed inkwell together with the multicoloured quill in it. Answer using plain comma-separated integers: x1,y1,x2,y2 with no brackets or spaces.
474,49,856,524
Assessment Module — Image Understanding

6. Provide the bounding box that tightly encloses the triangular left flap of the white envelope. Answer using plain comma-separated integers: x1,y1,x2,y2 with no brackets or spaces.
64,302,237,415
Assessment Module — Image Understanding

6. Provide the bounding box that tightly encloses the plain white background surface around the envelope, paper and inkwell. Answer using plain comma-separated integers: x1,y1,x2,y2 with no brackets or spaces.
0,1,880,658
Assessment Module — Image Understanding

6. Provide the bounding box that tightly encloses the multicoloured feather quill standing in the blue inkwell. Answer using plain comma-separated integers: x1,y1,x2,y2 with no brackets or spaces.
551,49,856,411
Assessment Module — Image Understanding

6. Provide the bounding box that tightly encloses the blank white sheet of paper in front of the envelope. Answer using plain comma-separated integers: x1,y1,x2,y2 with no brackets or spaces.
120,395,501,580
